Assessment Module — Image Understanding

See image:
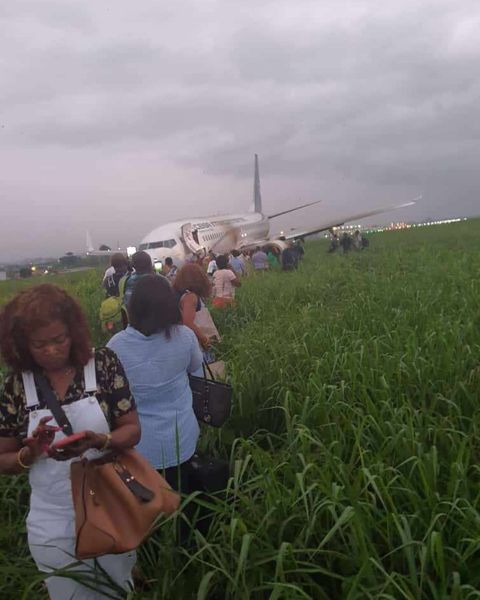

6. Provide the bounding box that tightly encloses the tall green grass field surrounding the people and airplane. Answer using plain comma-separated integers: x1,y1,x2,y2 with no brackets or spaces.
0,221,480,600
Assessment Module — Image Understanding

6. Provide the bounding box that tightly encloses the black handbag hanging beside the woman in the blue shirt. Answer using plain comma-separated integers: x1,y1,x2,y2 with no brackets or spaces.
189,363,232,427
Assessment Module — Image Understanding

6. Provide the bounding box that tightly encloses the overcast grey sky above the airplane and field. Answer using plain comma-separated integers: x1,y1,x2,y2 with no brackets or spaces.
0,0,480,263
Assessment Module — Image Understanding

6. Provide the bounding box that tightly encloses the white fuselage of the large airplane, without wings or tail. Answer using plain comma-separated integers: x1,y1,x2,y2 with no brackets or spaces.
138,212,269,265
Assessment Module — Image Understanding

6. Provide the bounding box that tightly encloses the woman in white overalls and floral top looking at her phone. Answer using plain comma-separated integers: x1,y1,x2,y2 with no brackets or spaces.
0,284,140,600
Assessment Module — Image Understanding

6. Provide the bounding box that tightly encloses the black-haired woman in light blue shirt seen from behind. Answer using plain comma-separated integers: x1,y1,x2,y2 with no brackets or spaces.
108,275,202,486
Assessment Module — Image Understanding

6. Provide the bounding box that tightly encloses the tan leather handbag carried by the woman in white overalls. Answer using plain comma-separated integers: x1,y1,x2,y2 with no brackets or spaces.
71,450,180,559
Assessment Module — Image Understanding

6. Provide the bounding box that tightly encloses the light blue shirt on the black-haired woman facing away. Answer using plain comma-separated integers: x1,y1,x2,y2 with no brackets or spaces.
108,325,202,469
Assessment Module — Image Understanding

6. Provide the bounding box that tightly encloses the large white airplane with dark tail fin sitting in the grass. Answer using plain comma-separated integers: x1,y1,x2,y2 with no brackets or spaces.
138,154,415,270
